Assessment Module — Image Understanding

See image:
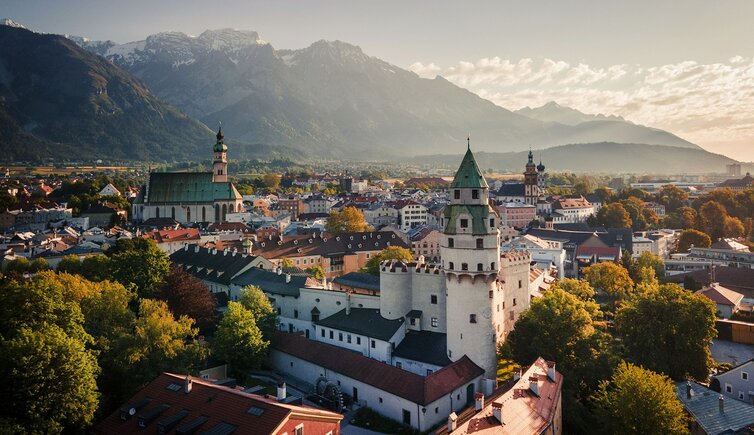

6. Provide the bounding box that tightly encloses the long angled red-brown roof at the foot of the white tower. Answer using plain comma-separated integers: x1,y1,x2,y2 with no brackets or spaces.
272,333,484,405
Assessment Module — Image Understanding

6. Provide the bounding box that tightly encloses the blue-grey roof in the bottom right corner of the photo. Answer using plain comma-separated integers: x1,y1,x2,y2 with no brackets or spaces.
675,381,754,435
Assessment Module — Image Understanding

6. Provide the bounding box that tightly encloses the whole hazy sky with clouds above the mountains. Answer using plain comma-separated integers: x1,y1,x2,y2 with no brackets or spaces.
5,0,754,160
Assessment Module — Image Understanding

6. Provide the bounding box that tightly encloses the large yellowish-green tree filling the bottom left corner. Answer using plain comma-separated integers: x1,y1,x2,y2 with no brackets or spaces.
0,323,99,434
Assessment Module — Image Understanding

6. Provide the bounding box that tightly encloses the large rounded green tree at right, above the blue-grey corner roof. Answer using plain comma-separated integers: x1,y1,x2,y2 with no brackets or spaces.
615,284,717,380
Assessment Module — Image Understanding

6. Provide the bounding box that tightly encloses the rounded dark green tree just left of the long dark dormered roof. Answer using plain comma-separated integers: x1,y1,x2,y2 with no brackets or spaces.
109,238,170,297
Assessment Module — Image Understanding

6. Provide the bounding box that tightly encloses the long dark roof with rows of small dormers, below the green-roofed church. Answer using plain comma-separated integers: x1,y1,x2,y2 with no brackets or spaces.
170,246,257,285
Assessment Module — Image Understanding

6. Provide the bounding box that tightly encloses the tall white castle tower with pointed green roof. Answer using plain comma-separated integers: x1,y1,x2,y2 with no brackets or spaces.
440,139,504,379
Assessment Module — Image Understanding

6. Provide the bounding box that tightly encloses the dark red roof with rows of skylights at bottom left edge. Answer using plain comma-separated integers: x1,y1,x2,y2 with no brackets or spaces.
91,373,343,434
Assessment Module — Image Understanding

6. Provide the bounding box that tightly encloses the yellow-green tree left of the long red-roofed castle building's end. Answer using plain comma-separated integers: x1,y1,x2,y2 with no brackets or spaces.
214,302,270,377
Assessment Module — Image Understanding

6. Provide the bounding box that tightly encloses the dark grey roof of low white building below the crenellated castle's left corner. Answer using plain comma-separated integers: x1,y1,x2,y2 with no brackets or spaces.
316,308,405,341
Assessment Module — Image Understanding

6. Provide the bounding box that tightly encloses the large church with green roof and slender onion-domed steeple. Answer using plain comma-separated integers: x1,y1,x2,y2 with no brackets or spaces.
132,130,243,223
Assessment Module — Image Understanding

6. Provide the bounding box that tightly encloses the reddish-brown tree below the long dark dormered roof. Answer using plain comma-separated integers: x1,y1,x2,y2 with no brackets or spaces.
155,267,217,331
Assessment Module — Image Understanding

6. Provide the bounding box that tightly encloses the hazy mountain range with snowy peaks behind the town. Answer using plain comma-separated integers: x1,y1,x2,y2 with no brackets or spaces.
0,22,740,171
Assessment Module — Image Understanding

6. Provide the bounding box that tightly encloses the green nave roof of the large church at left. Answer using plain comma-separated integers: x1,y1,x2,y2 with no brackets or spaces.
146,172,241,204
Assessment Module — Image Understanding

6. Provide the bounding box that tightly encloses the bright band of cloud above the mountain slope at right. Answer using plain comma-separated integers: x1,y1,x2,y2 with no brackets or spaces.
409,56,754,160
